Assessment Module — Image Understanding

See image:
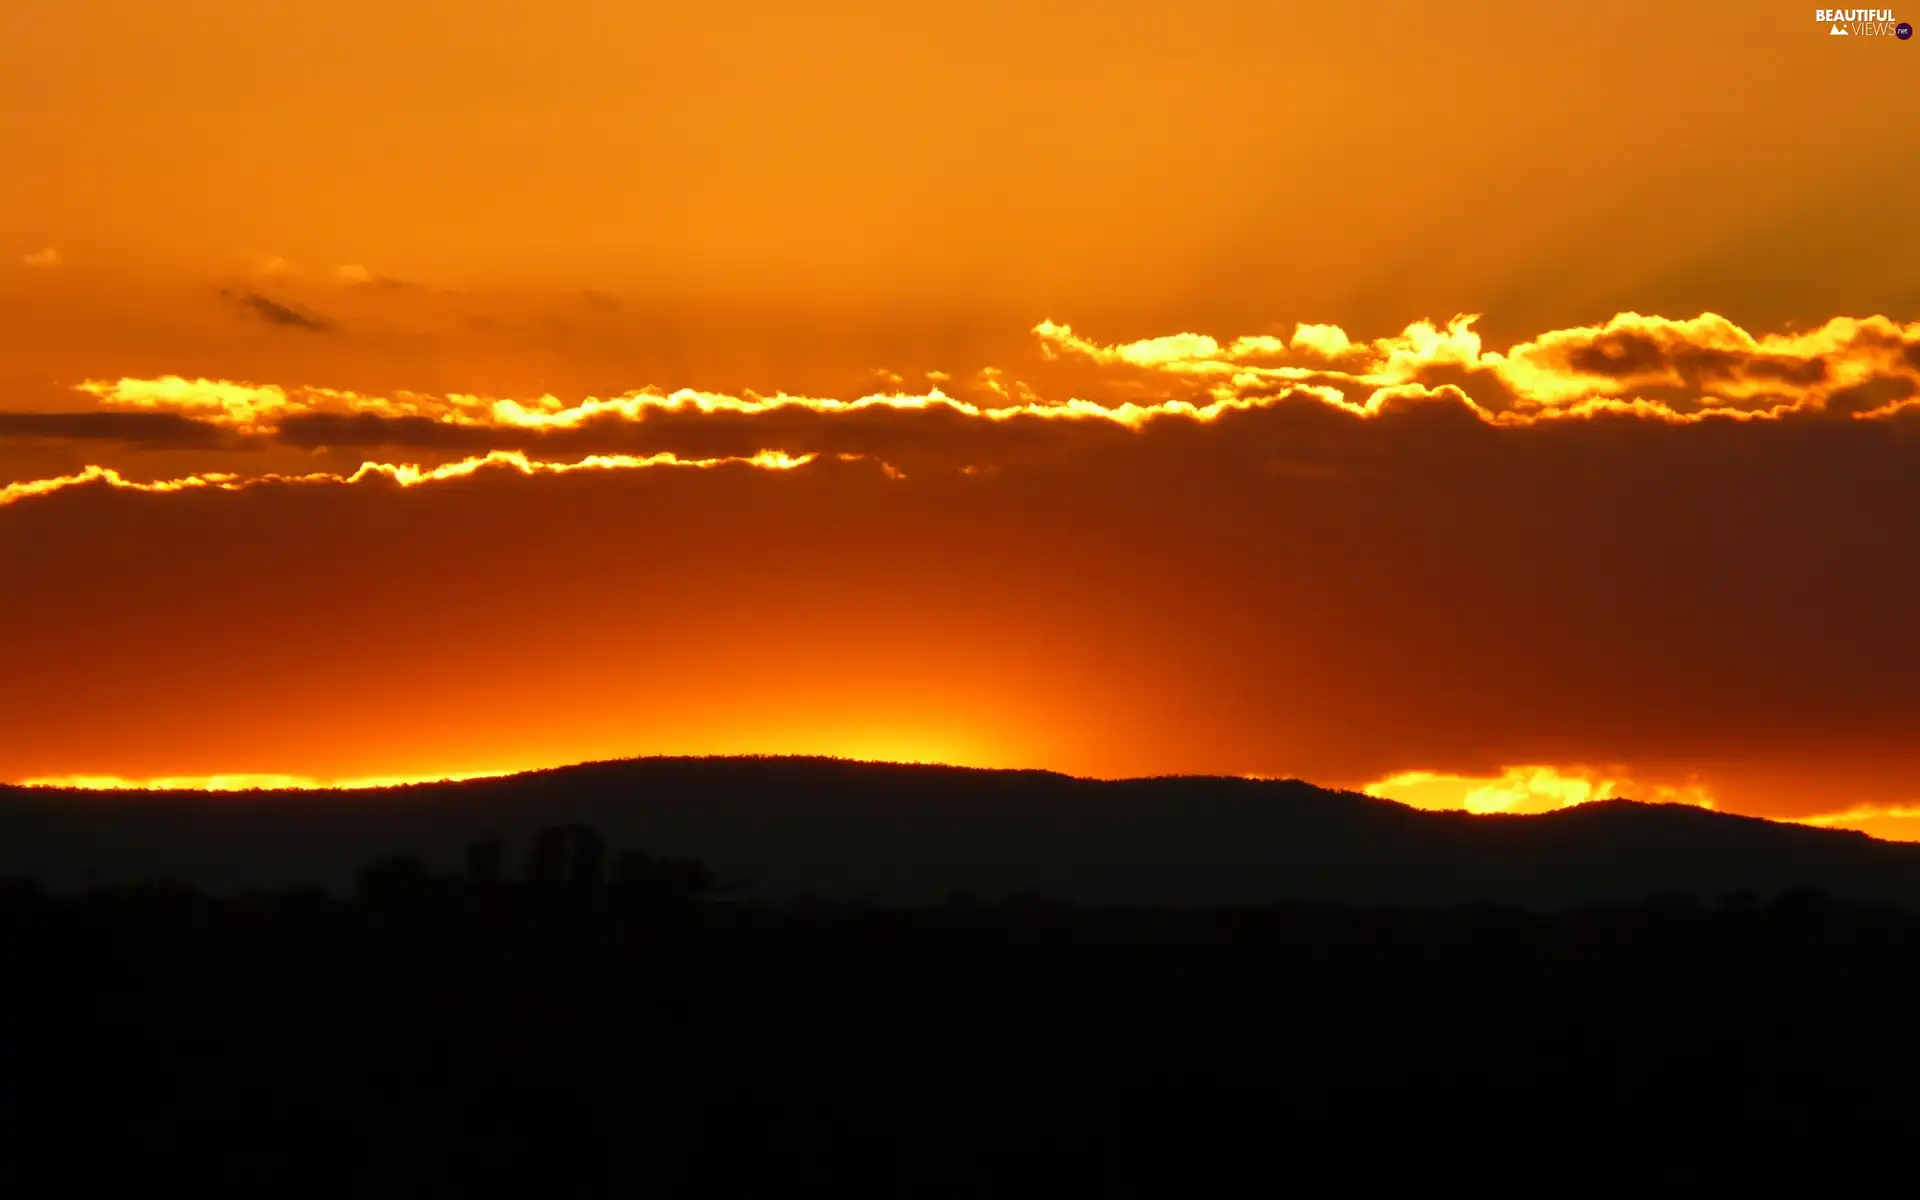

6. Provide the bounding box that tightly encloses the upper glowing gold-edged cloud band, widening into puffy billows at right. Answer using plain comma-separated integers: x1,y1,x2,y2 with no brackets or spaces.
60,309,1920,453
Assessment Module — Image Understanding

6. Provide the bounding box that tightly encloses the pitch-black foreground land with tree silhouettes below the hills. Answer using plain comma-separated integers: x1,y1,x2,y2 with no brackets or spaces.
0,826,1920,1196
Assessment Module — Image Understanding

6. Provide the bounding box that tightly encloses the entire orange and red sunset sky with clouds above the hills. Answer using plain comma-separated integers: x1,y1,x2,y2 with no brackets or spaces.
0,0,1920,839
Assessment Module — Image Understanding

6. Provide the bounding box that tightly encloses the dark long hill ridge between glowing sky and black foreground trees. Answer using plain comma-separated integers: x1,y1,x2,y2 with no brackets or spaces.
0,756,1920,908
